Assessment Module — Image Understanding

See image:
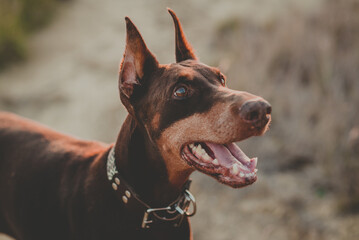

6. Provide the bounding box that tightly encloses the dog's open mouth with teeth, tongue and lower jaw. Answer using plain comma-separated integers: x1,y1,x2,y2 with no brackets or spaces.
181,142,257,188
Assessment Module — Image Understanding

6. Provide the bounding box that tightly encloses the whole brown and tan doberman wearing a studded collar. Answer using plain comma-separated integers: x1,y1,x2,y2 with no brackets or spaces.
0,9,271,240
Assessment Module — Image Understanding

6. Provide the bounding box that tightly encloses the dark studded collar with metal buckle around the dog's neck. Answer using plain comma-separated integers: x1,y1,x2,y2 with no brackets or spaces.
106,147,196,229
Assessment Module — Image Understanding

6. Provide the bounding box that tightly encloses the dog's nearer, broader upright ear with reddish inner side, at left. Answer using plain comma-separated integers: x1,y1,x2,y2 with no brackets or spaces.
119,17,158,98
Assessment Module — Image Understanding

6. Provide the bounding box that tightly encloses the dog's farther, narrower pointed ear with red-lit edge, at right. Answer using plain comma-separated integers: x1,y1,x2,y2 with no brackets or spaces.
167,8,197,62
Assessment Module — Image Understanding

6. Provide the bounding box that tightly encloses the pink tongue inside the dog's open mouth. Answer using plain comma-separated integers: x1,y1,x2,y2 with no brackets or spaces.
206,142,249,167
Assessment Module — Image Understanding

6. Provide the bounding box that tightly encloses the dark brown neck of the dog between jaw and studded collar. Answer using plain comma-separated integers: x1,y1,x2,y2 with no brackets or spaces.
115,115,188,207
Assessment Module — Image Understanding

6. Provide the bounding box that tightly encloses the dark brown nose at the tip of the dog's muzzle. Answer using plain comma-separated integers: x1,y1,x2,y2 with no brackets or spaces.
239,100,272,127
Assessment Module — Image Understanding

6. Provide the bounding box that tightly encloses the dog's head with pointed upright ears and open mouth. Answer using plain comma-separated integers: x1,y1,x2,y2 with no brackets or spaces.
119,9,271,187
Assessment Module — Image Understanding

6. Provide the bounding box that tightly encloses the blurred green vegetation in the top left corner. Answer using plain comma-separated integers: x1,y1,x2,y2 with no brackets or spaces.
0,0,67,69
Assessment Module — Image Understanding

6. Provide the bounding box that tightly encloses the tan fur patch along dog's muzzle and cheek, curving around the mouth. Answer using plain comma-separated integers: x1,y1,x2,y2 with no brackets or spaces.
157,100,247,185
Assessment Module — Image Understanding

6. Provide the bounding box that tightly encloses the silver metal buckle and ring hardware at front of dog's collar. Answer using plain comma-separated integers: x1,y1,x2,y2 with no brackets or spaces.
141,189,197,228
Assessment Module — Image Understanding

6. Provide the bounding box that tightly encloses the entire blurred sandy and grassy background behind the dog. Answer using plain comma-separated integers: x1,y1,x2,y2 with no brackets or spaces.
0,0,359,240
